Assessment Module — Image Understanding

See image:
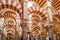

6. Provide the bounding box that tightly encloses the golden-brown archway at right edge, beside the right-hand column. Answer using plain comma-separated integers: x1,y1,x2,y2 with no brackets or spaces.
52,7,60,39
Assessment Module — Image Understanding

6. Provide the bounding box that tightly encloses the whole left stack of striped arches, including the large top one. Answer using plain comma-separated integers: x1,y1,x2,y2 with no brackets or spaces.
0,0,22,35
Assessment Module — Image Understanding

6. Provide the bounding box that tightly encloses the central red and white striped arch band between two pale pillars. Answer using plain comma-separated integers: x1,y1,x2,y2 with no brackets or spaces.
28,6,48,20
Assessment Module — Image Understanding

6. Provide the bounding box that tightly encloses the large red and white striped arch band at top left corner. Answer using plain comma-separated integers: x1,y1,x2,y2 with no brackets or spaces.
0,0,22,14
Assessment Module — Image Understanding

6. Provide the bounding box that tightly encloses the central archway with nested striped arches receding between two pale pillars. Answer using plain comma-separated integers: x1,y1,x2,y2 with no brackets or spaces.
27,3,48,37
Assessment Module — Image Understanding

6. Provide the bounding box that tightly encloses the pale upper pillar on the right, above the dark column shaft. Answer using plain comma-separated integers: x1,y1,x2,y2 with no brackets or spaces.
47,0,53,25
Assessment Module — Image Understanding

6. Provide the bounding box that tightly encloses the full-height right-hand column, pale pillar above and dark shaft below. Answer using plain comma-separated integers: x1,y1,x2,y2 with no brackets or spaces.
46,0,53,40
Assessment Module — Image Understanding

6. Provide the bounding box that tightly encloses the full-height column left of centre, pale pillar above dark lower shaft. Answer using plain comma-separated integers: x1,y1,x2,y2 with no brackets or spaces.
23,0,28,40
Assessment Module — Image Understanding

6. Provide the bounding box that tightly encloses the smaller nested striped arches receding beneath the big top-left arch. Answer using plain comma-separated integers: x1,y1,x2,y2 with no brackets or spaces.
3,11,22,36
